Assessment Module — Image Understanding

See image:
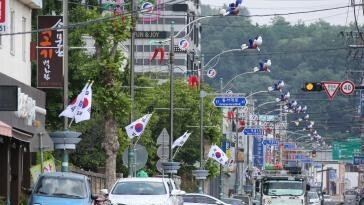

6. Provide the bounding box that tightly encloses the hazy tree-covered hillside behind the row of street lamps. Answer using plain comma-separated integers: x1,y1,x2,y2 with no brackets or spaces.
201,4,361,143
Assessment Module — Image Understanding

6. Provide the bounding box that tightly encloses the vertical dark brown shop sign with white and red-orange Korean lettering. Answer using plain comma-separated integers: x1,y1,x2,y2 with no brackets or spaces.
37,16,63,88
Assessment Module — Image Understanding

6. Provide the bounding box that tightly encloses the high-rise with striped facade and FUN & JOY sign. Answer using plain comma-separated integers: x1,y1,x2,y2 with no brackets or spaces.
125,0,201,74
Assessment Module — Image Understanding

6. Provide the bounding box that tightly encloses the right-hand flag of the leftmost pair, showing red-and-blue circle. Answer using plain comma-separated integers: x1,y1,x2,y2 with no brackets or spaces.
75,83,92,123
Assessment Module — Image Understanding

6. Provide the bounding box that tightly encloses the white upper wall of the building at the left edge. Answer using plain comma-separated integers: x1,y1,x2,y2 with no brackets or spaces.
0,0,31,85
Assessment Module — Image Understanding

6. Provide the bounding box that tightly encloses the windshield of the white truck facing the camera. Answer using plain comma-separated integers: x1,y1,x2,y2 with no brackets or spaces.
263,180,304,196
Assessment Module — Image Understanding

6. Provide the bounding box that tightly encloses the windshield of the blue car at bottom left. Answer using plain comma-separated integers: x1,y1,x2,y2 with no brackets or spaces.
35,176,86,198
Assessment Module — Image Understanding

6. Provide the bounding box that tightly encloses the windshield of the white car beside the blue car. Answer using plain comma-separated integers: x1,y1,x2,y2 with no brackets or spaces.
111,181,167,195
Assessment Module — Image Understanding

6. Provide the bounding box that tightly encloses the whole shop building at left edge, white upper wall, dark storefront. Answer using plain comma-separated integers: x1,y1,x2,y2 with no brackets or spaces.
0,0,45,204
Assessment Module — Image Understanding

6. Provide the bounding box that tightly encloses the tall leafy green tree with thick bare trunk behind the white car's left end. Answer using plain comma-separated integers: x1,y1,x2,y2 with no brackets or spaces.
70,7,131,187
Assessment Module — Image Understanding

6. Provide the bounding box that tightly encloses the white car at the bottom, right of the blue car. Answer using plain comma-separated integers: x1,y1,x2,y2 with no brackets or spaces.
109,177,185,205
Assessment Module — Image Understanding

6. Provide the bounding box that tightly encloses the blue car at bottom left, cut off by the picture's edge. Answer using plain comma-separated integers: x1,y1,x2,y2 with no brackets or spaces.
29,172,97,205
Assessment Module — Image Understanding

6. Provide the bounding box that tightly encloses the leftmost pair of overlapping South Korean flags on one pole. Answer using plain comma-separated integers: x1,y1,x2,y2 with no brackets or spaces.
58,81,94,123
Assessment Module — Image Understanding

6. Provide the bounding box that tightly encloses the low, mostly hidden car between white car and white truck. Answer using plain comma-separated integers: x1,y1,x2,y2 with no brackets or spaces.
183,193,231,205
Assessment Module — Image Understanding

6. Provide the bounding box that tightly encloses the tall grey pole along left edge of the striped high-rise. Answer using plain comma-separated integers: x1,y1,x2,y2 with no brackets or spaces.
128,0,137,177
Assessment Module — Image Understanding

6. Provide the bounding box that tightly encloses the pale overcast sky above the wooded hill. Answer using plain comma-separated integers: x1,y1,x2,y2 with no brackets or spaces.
201,0,356,25
